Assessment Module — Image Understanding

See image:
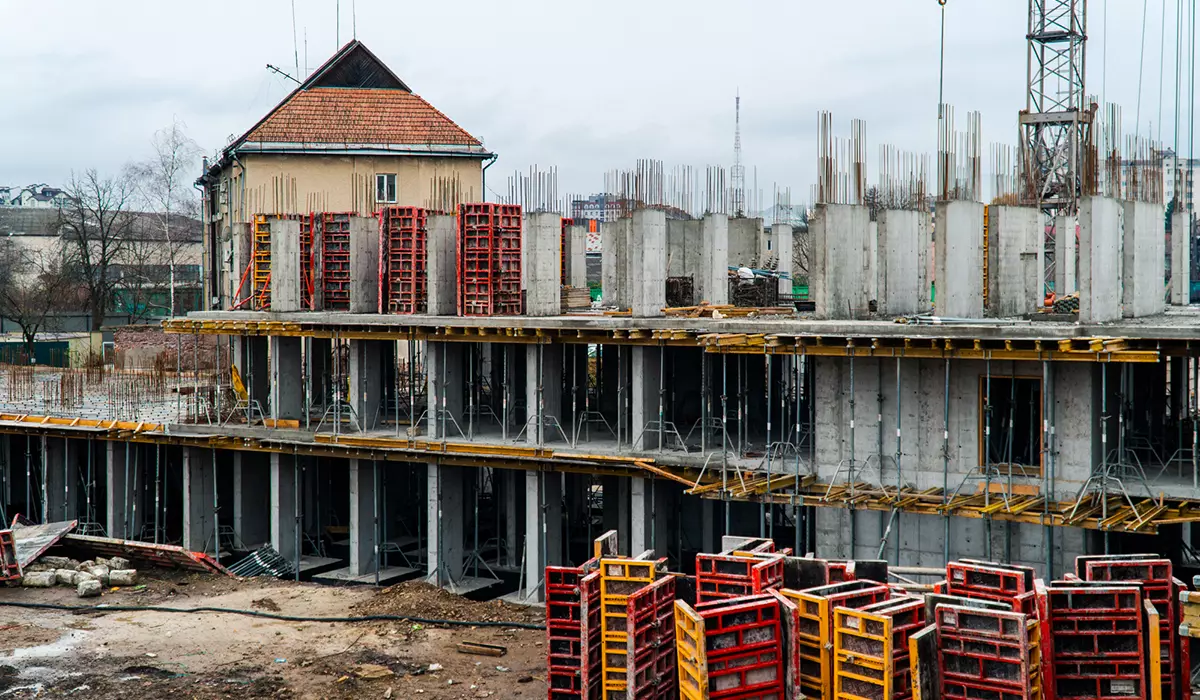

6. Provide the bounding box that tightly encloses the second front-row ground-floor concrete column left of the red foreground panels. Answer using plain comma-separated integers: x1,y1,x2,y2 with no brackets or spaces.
426,462,467,586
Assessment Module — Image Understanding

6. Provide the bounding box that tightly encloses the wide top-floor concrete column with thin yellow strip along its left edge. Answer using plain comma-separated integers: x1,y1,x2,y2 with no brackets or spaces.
988,207,1045,317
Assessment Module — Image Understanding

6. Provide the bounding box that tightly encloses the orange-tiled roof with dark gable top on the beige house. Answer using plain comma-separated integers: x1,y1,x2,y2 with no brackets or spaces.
223,40,491,160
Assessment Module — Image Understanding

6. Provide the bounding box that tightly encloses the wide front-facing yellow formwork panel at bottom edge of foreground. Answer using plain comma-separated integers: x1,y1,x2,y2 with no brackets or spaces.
824,608,894,700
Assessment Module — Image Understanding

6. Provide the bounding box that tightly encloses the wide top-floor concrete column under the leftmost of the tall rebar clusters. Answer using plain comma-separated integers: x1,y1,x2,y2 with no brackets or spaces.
809,204,870,318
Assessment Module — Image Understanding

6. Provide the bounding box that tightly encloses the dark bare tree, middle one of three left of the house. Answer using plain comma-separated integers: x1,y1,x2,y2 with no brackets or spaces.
59,169,134,330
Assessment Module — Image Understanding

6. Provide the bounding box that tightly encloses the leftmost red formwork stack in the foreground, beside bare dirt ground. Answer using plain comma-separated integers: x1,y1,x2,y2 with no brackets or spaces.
546,560,600,700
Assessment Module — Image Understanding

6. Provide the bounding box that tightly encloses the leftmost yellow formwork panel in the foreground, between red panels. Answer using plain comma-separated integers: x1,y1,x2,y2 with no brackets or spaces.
600,558,658,699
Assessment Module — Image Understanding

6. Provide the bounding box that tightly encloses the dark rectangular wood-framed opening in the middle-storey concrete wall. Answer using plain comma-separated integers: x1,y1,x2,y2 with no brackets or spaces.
979,376,1042,475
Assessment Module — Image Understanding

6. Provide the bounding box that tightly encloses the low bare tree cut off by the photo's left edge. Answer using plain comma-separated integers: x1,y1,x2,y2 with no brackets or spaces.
0,238,74,358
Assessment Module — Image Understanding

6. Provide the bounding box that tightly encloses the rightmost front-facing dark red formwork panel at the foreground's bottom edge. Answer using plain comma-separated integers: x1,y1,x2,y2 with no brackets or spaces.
1046,581,1147,700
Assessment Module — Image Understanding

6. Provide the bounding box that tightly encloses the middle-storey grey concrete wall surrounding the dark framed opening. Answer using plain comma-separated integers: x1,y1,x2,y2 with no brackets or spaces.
812,358,1099,498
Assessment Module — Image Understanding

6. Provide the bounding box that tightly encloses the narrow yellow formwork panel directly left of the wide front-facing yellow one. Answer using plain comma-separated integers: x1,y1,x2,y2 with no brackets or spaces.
780,581,892,698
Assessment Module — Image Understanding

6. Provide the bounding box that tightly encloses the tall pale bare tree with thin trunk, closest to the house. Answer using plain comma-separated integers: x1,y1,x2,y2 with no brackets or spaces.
132,119,202,316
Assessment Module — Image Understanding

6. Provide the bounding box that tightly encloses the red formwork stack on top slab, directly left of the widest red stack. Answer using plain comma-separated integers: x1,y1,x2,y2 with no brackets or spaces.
379,207,428,313
